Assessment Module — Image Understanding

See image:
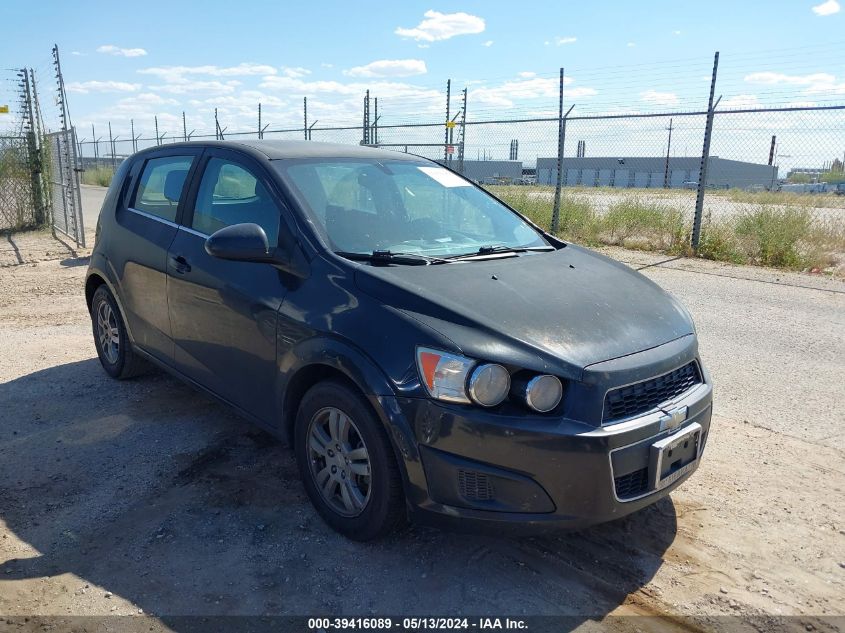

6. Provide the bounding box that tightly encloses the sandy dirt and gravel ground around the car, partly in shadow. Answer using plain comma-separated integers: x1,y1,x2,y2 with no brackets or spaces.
0,225,845,631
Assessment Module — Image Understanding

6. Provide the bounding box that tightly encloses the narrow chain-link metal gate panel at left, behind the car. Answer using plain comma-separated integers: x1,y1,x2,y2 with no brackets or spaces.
45,128,85,247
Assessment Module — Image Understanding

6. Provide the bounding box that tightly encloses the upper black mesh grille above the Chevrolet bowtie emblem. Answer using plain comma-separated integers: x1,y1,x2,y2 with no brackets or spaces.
602,361,701,423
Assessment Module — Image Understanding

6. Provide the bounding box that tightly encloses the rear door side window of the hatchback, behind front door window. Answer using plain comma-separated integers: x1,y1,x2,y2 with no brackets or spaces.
130,156,193,222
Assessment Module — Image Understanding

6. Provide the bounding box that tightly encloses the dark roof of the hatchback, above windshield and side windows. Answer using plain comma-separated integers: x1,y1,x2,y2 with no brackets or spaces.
144,139,426,162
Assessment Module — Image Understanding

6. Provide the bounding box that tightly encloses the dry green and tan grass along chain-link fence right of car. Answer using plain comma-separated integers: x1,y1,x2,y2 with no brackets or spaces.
489,186,845,276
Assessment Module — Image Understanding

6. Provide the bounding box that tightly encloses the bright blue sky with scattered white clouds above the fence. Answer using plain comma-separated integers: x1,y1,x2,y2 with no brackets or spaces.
0,0,845,167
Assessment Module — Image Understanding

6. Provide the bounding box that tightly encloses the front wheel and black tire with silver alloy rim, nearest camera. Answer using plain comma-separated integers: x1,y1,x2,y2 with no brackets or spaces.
294,381,405,541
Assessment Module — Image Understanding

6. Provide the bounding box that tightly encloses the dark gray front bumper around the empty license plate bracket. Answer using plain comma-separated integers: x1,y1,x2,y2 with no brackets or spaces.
383,366,712,529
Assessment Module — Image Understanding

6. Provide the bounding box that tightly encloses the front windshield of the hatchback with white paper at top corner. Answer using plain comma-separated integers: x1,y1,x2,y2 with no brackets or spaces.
273,159,548,257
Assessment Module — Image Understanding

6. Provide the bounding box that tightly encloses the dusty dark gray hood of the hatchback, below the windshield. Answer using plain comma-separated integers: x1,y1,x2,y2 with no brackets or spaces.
355,244,693,377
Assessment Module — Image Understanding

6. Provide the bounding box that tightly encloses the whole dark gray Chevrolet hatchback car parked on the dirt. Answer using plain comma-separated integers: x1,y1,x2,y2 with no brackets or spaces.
85,141,712,540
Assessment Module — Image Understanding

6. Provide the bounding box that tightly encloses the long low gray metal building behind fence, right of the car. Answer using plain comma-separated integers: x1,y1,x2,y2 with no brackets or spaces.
537,156,777,189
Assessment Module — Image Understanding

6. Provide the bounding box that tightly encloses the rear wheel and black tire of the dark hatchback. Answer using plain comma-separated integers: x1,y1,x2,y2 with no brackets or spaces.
91,284,149,380
